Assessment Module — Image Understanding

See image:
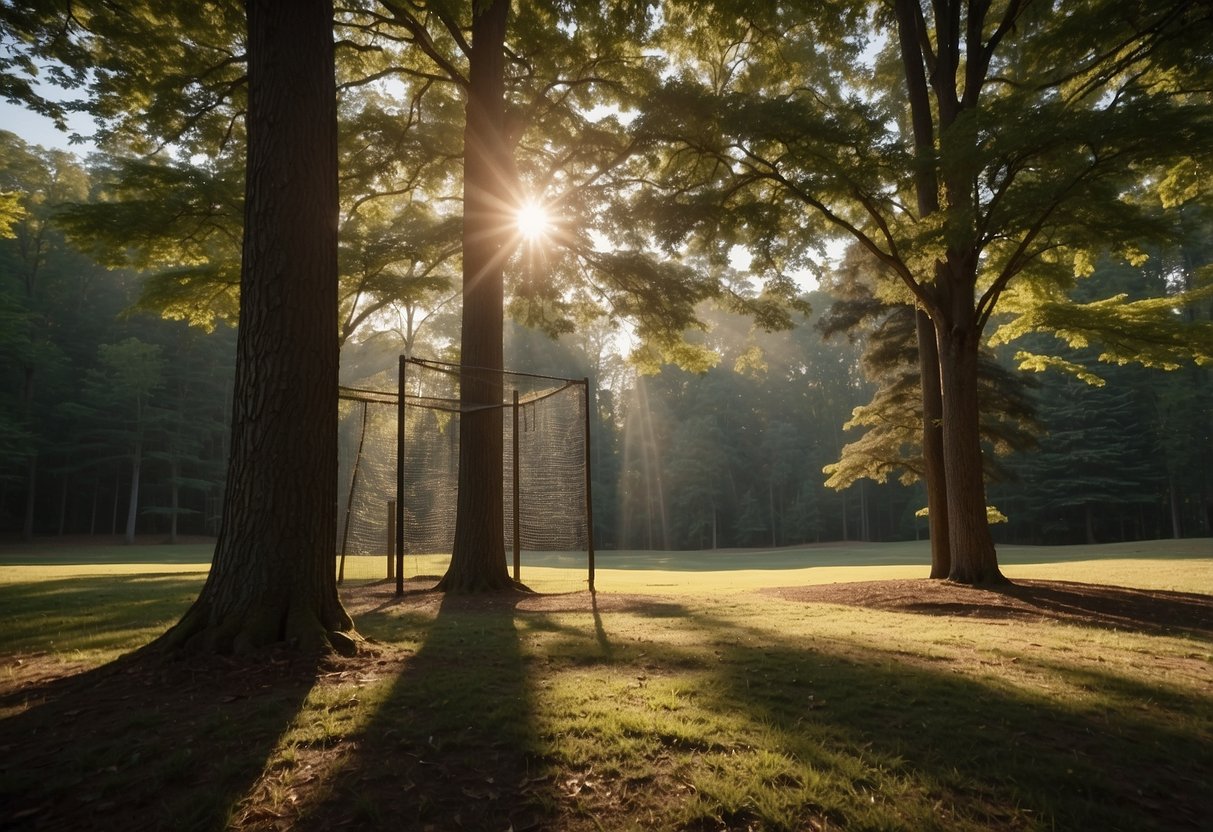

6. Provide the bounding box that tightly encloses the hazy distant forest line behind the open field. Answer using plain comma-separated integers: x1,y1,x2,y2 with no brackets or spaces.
7,127,1213,549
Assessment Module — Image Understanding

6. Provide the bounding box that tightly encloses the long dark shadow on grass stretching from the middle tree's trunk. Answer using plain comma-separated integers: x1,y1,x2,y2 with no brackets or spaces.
292,594,551,831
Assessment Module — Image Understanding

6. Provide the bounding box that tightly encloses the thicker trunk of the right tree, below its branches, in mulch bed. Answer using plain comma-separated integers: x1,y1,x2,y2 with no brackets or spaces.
938,317,1006,585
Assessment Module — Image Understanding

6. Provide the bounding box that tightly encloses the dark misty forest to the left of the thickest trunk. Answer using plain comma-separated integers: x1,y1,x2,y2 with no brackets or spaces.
0,132,234,538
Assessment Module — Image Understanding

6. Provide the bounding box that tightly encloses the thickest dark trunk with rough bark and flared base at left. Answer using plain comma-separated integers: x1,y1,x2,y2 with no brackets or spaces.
165,0,357,654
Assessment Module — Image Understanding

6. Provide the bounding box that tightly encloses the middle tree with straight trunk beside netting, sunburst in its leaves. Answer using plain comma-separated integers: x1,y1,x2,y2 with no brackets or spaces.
397,0,732,592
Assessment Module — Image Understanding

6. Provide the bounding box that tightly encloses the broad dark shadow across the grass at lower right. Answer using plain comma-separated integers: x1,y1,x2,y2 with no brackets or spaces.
665,620,1213,830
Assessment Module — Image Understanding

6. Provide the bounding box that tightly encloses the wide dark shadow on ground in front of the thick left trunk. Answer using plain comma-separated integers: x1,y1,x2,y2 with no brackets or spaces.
0,653,317,832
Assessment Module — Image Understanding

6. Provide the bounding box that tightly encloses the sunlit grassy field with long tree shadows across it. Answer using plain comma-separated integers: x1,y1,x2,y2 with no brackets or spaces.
0,540,1213,832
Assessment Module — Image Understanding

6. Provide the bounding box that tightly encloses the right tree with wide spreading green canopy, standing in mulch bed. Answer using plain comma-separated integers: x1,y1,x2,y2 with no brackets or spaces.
640,0,1213,583
